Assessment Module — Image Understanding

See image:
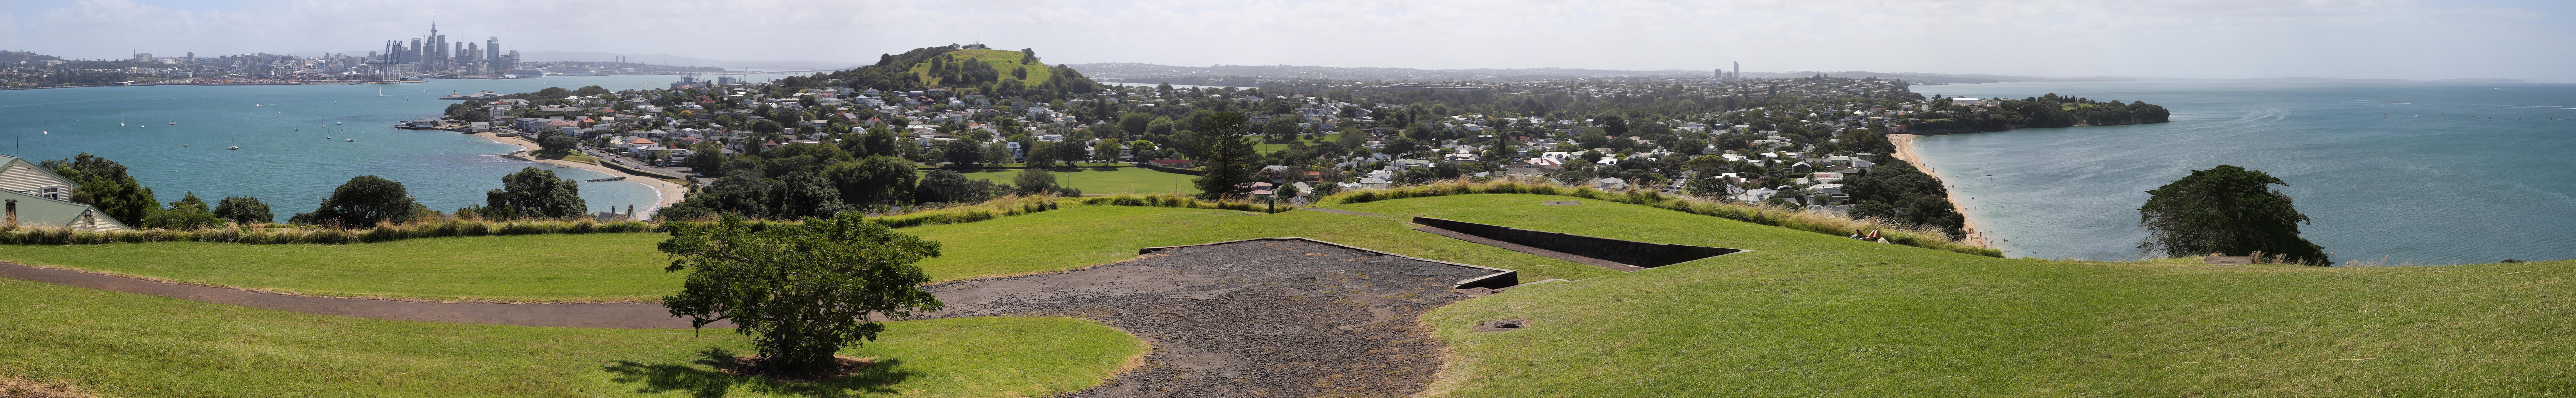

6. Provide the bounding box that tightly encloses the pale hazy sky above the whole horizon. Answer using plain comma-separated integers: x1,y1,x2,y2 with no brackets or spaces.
0,0,2576,82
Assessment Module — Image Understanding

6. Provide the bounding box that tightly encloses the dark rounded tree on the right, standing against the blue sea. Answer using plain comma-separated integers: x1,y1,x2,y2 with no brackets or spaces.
2138,164,2331,265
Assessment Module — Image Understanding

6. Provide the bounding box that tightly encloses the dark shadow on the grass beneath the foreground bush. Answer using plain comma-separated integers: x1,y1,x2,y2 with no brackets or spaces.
600,349,920,398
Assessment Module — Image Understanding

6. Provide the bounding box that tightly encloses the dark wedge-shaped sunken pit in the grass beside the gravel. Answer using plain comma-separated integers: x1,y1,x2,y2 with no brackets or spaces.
1414,216,1744,267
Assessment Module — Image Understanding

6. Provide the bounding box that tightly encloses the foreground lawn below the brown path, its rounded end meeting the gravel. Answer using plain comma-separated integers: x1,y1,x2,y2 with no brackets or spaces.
0,280,1144,398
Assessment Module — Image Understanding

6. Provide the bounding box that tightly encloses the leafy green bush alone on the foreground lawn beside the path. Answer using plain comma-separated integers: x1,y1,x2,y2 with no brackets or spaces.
659,213,943,375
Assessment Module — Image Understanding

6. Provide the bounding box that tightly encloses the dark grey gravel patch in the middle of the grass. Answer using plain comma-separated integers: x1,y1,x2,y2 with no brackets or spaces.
927,239,1517,398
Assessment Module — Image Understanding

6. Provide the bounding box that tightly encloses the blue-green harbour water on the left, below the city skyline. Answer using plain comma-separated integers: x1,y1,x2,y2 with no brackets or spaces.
0,74,770,221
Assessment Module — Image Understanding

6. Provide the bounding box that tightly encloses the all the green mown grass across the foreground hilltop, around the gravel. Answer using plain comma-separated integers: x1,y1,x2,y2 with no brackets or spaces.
0,195,2576,395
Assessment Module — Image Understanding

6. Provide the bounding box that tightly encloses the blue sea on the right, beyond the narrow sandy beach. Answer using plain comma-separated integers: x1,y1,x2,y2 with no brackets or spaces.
1914,82,2576,265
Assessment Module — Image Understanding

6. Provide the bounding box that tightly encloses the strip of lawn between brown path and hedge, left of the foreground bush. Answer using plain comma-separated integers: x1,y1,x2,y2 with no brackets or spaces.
0,234,683,300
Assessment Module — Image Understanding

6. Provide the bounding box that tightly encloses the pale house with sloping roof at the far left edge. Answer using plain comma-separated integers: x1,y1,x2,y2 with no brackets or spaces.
0,154,131,231
